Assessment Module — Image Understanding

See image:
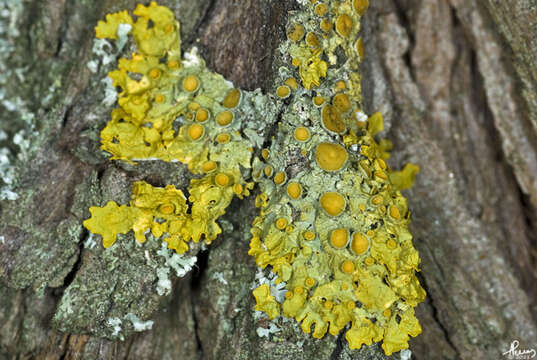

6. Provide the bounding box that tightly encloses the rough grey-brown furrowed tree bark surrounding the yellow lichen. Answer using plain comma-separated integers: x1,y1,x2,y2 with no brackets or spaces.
0,0,537,360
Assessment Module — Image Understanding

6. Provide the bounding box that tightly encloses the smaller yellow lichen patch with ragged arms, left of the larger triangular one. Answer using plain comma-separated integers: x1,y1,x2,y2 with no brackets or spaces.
84,2,263,254
